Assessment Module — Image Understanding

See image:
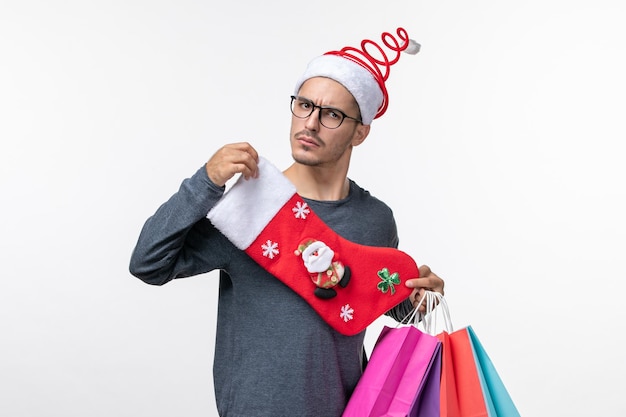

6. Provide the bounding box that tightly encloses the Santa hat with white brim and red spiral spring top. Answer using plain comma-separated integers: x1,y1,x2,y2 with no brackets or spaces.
295,28,420,125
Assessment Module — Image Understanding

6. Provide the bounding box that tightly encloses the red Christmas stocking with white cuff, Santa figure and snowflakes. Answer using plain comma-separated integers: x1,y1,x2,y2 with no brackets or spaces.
207,158,419,336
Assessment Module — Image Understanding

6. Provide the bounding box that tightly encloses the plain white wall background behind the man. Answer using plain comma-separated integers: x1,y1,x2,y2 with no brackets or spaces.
0,0,626,417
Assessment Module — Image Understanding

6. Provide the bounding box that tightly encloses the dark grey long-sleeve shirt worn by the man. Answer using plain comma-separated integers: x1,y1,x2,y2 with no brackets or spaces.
130,167,411,417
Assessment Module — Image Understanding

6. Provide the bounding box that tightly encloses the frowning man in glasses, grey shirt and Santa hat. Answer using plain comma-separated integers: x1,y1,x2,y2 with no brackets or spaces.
130,29,444,417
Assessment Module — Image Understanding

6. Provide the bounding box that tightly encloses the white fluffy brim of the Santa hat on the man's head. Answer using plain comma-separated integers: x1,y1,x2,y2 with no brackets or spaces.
295,55,383,125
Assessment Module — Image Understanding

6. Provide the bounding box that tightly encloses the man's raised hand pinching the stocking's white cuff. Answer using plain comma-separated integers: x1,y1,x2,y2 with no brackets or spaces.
205,142,259,187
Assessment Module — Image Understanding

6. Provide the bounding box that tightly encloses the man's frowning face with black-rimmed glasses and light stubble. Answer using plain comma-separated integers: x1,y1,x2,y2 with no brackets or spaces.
290,77,369,166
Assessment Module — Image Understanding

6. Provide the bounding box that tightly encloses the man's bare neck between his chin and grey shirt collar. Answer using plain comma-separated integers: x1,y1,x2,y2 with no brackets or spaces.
283,163,350,201
